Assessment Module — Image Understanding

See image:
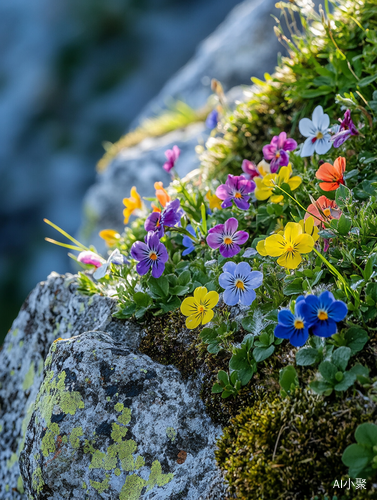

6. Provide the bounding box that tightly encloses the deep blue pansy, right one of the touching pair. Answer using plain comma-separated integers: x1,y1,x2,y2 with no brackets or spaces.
305,292,347,337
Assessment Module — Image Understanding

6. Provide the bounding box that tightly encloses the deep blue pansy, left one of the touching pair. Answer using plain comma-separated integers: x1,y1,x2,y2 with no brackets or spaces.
274,295,309,347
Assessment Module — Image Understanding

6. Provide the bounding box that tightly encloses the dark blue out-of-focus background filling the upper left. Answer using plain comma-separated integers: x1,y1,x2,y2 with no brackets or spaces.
0,0,247,343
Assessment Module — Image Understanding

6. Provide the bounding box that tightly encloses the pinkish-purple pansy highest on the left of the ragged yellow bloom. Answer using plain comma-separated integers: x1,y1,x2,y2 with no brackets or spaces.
216,174,255,210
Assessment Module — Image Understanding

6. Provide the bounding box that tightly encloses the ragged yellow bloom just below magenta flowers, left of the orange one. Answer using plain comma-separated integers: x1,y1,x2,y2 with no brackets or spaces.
254,164,302,203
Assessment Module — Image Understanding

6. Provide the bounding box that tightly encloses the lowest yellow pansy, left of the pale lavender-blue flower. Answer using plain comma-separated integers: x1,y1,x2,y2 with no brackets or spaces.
181,286,219,330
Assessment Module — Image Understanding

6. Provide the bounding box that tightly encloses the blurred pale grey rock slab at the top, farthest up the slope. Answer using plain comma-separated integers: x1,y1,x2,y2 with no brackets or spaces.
133,0,285,126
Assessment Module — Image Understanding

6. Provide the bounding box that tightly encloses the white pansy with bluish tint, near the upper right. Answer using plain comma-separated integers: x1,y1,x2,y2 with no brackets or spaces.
298,106,332,156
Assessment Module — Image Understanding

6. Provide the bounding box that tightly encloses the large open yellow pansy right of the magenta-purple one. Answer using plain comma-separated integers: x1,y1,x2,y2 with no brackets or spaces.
264,222,314,269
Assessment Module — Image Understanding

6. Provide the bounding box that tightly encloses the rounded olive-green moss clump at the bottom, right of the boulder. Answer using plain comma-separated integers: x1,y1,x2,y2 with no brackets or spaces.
215,389,376,500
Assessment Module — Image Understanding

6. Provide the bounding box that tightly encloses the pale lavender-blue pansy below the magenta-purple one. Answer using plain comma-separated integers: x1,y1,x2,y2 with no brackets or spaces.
219,262,263,306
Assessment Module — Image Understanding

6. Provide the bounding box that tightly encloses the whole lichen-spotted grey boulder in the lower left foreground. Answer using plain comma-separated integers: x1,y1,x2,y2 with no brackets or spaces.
0,273,225,500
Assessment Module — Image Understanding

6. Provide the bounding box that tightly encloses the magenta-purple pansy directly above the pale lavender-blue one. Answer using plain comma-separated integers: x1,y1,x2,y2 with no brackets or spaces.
207,217,249,257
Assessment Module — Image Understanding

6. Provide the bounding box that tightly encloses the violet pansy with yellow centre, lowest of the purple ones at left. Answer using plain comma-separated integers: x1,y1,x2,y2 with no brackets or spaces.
131,231,169,278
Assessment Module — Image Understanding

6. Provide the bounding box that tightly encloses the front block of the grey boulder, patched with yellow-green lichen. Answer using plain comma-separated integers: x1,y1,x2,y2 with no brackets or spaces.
20,332,220,500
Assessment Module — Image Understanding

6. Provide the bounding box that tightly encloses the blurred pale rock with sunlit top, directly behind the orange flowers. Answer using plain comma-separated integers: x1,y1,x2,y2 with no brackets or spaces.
83,119,208,248
